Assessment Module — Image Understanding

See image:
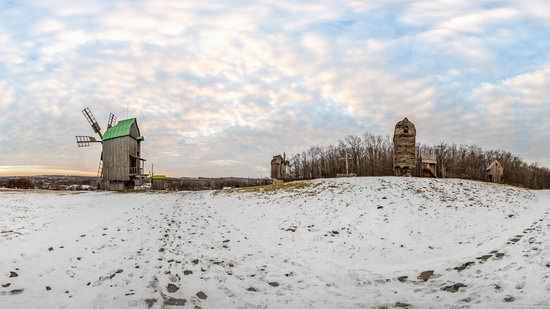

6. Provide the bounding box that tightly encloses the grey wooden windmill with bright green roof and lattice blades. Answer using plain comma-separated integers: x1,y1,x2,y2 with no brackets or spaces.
76,108,146,190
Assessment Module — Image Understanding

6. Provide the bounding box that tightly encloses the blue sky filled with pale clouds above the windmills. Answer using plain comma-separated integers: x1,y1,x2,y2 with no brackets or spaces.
0,0,550,177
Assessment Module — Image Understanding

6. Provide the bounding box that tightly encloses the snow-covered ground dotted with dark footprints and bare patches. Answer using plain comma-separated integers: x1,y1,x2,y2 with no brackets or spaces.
0,177,550,308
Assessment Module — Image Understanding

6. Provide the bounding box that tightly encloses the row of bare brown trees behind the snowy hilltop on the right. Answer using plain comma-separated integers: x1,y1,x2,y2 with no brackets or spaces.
287,133,550,189
